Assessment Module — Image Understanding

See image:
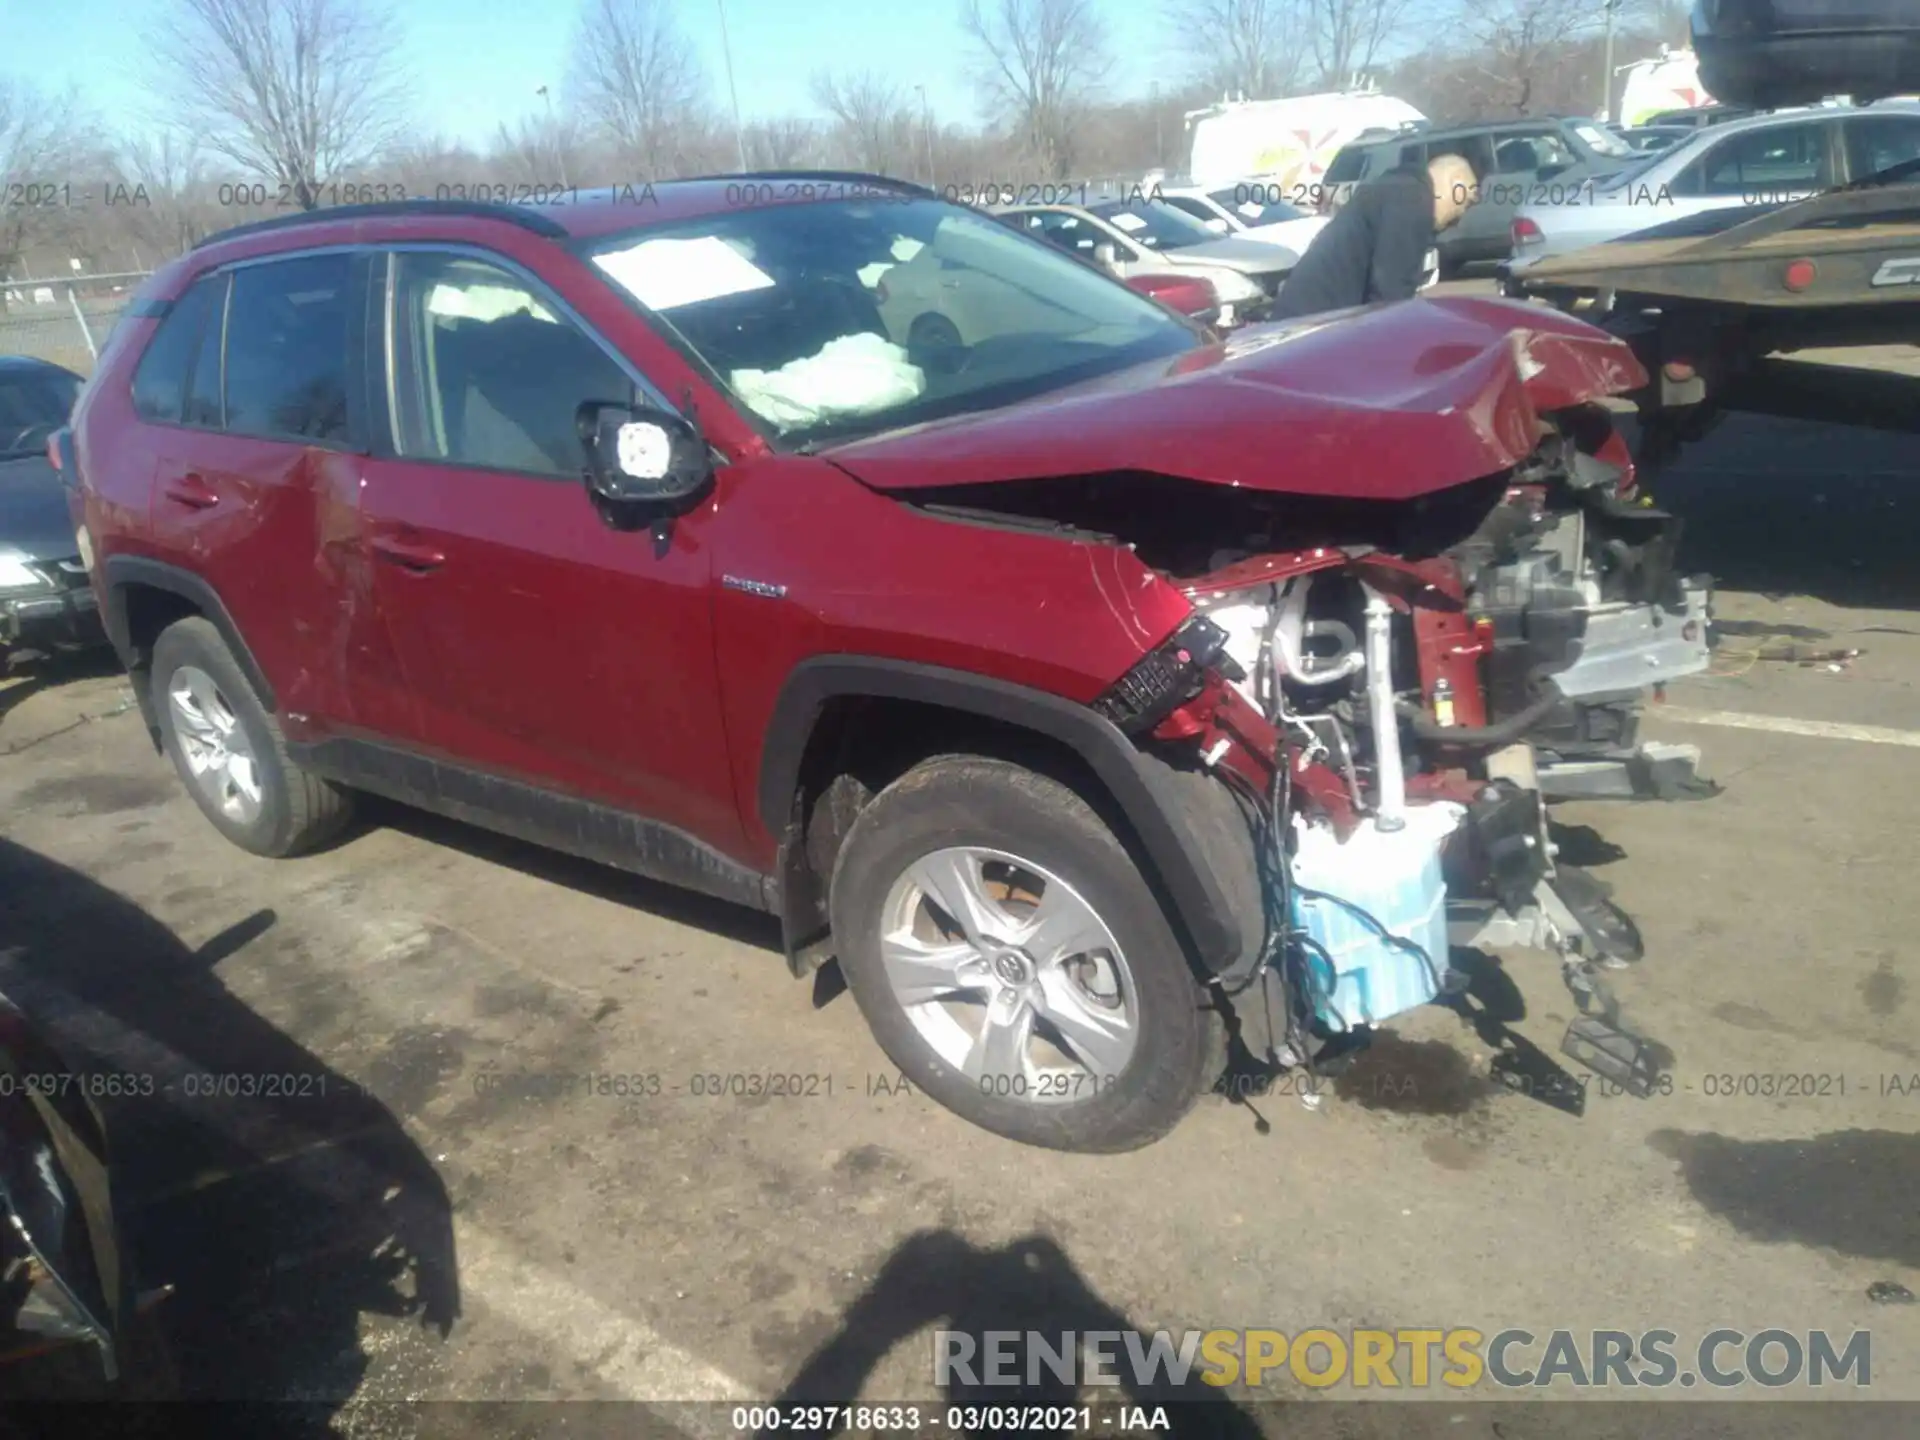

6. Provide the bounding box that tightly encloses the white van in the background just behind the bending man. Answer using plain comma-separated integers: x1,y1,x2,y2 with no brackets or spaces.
1187,90,1427,194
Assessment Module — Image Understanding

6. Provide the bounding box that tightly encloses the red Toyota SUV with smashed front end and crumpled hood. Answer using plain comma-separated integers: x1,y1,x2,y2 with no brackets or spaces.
54,175,1672,1150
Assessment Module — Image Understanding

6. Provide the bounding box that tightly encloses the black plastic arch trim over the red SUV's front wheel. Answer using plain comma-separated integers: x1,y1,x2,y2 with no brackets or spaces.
756,655,1248,973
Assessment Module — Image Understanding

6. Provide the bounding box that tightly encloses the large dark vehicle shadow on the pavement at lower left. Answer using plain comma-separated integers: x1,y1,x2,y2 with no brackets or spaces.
0,839,461,1419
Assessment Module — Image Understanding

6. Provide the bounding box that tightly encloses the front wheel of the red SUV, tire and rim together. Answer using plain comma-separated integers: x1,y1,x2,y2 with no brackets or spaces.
831,756,1217,1152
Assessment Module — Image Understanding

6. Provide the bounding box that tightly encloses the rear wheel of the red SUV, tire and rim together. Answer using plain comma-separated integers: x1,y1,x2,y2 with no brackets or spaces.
152,614,353,858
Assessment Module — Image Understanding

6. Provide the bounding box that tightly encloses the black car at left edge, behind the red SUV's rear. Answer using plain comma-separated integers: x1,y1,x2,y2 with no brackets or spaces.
0,355,102,664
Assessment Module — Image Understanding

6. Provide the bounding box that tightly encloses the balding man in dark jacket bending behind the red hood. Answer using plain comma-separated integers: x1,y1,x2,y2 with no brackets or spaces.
1273,156,1478,321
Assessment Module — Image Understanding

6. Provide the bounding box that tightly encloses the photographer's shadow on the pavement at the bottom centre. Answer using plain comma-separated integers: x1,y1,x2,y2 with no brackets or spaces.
776,1231,1261,1440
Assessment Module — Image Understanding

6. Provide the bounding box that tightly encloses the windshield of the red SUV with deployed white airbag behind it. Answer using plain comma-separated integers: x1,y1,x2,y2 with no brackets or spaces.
588,198,1206,449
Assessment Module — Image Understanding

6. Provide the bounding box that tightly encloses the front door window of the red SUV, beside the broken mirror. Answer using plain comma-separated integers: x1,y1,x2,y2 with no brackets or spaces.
388,252,634,480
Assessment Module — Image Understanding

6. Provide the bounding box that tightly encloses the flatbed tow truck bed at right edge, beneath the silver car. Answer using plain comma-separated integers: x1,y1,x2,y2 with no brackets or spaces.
1501,161,1920,474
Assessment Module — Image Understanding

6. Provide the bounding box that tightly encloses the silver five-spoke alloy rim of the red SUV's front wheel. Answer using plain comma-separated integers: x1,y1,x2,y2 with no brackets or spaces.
879,847,1140,1104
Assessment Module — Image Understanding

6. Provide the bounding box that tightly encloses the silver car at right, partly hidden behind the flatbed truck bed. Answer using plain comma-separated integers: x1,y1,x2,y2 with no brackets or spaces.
1511,100,1920,271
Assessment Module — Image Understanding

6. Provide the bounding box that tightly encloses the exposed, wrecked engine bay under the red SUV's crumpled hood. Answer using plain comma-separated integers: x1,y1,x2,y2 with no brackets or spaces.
913,413,1707,1094
